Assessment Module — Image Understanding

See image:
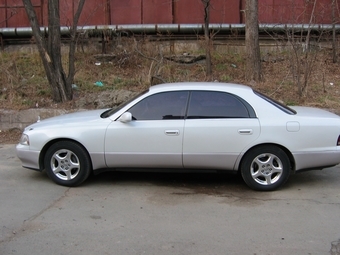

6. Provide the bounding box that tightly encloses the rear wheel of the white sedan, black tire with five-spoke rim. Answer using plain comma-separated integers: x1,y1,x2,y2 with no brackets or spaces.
240,145,291,191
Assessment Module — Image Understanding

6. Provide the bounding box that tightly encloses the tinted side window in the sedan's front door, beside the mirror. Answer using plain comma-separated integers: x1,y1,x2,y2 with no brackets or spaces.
129,91,189,120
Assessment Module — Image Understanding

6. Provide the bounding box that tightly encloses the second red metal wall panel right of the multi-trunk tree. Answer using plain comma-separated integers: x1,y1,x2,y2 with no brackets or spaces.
109,0,142,24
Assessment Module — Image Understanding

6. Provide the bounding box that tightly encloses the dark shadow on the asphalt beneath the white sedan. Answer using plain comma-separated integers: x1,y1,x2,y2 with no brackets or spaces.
85,170,338,195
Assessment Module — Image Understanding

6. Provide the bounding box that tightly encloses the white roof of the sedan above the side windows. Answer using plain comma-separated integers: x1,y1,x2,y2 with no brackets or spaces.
149,82,252,92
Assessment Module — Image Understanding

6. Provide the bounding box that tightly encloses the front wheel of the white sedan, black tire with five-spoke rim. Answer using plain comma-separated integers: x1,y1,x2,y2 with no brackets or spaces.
44,141,92,187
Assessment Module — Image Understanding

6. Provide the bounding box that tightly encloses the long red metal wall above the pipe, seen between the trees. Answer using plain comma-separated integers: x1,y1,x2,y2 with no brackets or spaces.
0,0,340,27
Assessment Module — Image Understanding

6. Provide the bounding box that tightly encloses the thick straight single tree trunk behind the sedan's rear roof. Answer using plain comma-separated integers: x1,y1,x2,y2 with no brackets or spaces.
245,0,262,81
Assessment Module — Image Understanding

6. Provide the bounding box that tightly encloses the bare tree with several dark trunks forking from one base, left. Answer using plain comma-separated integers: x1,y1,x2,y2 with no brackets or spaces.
23,0,85,102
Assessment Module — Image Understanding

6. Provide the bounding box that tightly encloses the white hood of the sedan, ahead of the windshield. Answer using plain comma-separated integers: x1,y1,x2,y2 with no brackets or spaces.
26,109,105,129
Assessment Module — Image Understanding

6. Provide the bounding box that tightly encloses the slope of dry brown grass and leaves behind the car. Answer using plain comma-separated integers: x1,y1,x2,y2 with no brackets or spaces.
0,37,340,109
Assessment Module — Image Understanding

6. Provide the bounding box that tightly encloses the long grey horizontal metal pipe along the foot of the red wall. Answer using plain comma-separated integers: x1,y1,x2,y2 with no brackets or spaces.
0,24,340,38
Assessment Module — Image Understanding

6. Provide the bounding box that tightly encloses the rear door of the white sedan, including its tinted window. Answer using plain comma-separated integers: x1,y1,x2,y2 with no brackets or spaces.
183,91,260,169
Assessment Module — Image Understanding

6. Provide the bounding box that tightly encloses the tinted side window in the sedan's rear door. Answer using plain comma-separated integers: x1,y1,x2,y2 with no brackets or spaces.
188,91,249,119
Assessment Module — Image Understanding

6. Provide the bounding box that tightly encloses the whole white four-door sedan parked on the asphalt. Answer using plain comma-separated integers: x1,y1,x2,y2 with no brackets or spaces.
16,82,340,191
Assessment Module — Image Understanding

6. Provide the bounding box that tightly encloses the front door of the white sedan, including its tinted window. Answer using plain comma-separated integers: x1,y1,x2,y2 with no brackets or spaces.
105,91,189,168
